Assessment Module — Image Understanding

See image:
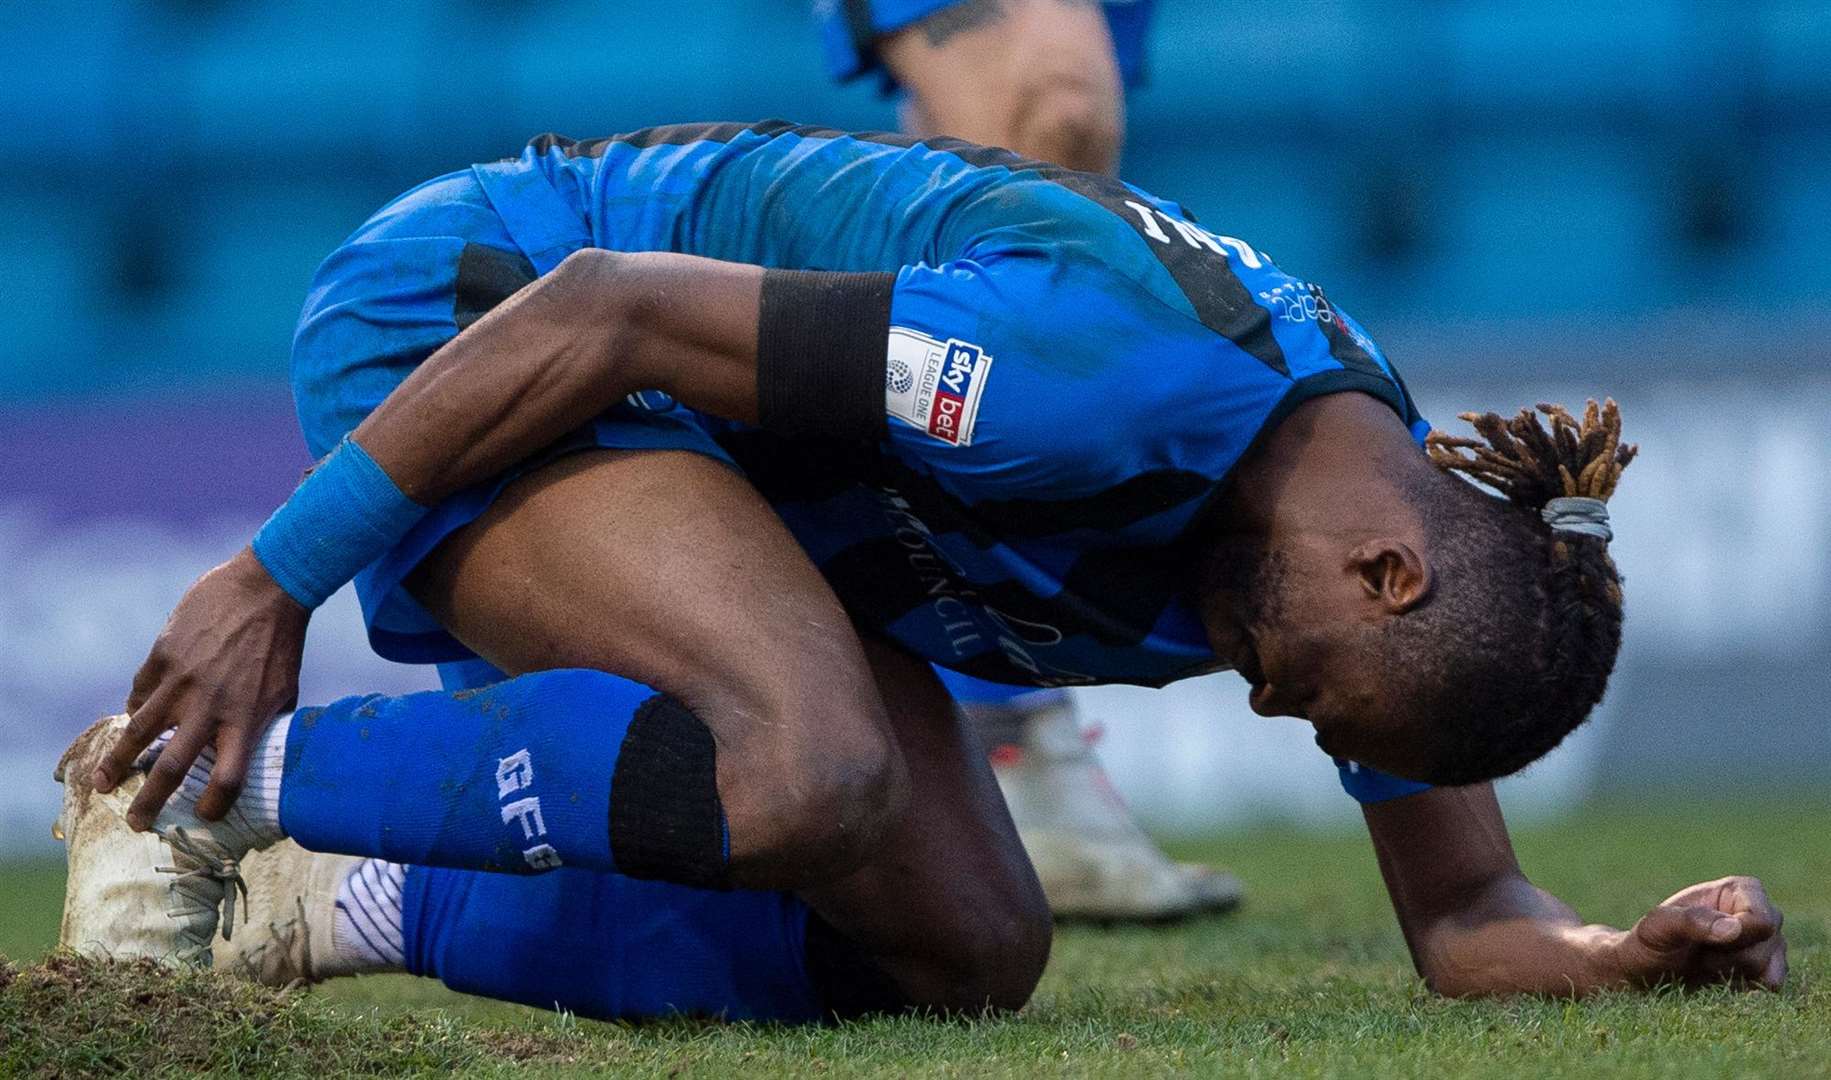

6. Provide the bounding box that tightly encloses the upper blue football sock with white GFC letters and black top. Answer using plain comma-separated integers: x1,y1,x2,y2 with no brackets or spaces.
280,670,731,886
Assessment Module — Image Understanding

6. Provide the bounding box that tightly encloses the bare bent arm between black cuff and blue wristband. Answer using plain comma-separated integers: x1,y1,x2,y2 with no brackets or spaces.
352,249,762,505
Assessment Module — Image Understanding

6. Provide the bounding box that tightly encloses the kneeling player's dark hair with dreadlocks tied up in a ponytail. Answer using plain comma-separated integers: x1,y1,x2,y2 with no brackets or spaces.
1384,401,1637,785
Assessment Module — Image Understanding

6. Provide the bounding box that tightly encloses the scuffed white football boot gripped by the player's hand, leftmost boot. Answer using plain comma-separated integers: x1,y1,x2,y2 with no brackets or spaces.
51,716,267,967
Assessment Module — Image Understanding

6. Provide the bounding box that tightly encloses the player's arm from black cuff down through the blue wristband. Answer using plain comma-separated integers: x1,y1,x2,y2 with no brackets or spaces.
234,249,780,611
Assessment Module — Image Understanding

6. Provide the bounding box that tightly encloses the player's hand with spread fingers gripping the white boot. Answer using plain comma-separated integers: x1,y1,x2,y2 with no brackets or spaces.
93,547,311,829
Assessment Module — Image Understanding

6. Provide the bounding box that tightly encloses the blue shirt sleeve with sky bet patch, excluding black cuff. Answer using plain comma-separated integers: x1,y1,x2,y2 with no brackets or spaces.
883,247,1252,500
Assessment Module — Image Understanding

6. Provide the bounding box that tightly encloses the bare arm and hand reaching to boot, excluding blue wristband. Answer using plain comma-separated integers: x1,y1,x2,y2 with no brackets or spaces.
95,249,764,827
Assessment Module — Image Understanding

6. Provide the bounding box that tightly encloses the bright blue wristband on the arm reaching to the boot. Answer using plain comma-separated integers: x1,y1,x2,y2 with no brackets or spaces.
253,437,427,608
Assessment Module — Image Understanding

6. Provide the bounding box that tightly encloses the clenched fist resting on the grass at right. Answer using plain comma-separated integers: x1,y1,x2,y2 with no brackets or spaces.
1609,877,1787,990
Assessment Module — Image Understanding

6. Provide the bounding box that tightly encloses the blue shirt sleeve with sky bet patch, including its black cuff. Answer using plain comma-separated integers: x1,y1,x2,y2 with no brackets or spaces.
756,247,1179,496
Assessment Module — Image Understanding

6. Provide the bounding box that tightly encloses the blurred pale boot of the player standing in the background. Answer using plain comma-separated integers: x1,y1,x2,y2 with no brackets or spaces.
963,699,1241,921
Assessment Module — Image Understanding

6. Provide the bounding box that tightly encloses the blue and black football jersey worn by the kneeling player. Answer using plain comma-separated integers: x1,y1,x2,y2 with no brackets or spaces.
509,123,1428,686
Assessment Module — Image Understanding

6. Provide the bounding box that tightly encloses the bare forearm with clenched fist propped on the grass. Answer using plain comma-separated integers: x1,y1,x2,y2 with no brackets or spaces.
1364,783,1787,998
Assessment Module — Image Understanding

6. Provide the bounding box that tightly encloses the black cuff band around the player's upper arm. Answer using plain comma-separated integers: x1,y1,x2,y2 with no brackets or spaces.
756,269,897,441
